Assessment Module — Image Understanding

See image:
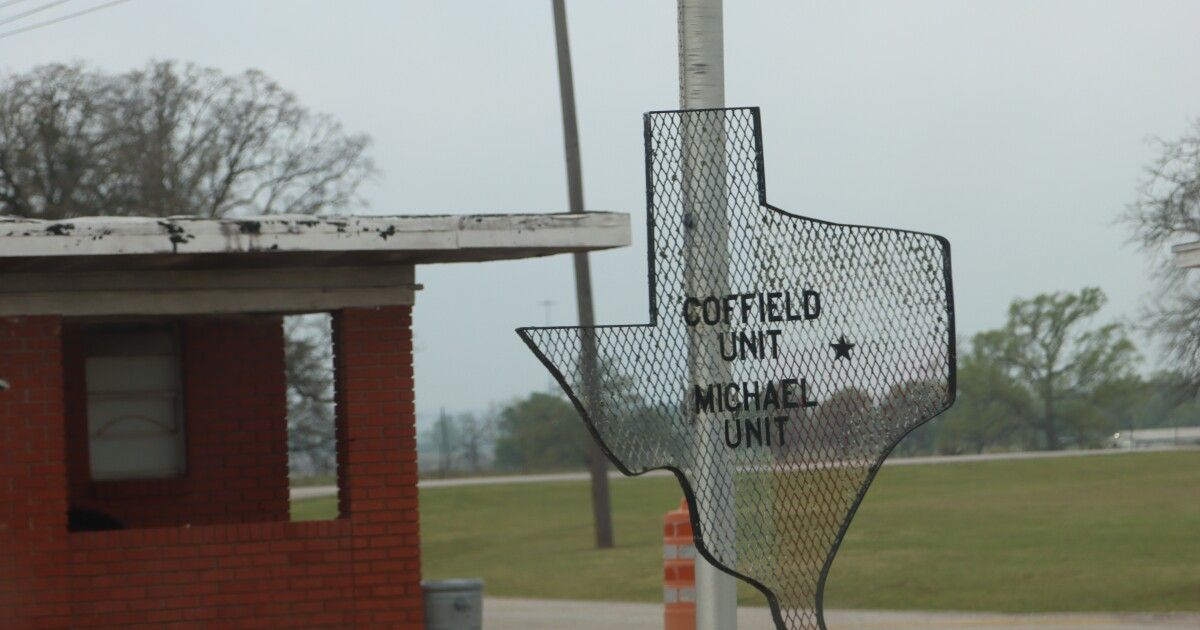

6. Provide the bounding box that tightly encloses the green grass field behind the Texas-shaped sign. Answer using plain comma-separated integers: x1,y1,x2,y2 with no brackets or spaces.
294,451,1200,612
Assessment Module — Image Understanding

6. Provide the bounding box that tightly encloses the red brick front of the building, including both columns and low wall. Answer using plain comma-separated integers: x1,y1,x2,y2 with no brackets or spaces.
0,307,422,630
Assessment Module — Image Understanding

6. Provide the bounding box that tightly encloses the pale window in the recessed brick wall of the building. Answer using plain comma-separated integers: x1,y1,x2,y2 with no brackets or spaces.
84,325,186,481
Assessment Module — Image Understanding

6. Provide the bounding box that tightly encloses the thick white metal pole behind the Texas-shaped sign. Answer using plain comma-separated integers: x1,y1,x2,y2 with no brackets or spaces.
678,0,738,630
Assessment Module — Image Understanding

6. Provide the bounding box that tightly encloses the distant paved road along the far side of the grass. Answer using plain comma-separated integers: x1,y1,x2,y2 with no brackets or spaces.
292,448,1190,499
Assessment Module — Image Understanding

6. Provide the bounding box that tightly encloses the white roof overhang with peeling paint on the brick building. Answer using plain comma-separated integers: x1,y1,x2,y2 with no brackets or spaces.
0,212,630,316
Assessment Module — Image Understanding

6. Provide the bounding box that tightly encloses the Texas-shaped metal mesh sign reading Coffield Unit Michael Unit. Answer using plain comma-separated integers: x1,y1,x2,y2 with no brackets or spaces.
517,108,954,630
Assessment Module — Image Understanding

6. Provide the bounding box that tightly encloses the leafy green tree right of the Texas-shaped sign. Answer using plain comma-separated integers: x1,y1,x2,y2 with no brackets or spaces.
973,288,1138,450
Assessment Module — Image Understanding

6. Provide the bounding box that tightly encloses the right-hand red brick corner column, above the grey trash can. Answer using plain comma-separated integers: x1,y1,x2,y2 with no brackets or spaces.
332,306,424,629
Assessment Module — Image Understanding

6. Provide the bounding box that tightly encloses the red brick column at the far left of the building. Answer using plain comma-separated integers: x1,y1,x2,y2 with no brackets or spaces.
0,317,70,628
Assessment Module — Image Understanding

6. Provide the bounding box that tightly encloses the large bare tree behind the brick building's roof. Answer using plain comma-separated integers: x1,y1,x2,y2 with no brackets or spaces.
0,61,374,472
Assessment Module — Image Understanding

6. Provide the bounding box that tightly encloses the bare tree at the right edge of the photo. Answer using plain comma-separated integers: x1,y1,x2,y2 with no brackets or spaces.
1123,118,1200,391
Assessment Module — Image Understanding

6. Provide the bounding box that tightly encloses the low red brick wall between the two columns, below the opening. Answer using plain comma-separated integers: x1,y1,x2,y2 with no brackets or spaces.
63,521,360,629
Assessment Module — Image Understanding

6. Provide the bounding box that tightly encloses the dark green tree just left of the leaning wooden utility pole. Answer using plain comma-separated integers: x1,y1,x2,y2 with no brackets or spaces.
496,392,592,472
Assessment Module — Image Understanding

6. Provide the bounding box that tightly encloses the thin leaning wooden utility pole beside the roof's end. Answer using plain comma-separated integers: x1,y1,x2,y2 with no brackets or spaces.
551,0,613,548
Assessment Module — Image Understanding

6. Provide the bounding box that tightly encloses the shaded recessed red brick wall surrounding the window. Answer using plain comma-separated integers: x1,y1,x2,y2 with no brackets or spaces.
64,317,288,527
